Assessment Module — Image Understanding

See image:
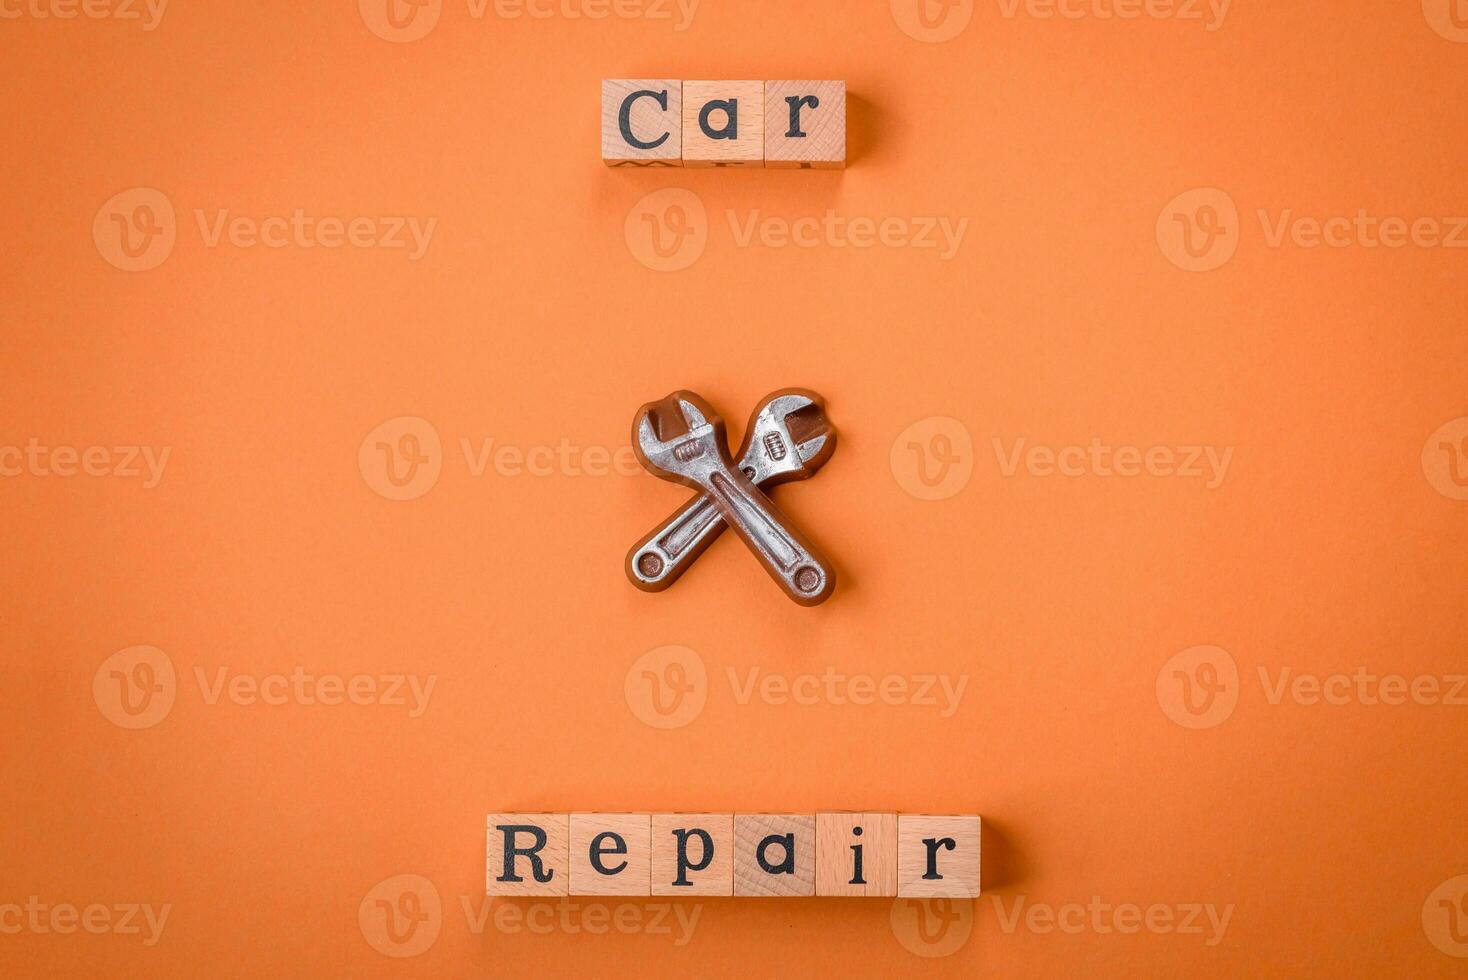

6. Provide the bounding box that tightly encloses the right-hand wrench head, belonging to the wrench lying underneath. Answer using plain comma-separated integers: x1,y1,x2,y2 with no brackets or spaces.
738,387,835,486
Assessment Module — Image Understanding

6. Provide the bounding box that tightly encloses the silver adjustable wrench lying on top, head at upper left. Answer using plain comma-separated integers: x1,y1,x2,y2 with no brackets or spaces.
633,392,835,606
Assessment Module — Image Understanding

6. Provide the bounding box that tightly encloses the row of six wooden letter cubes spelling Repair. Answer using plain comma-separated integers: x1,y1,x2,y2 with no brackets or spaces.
486,811,981,898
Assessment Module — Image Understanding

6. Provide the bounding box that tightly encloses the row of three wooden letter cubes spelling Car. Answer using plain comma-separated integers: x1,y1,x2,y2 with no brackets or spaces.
602,78,846,170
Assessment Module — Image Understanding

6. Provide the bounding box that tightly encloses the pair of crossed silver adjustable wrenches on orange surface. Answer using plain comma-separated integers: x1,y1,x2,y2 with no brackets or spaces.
627,389,835,606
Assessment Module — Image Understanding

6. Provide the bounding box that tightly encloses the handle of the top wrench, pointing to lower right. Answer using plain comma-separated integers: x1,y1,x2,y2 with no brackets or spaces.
706,468,835,606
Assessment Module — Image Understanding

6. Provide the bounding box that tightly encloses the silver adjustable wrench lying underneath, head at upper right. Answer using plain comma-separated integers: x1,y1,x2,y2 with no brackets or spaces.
627,387,835,593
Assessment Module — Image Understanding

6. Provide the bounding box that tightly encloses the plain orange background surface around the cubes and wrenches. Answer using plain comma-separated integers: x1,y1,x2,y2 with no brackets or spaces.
0,0,1468,977
